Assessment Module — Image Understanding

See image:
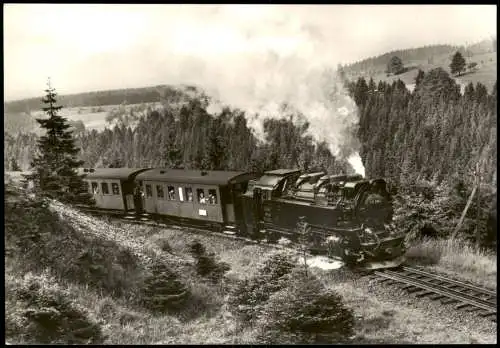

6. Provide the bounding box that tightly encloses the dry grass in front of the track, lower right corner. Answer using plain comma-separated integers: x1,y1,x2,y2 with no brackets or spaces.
314,269,496,344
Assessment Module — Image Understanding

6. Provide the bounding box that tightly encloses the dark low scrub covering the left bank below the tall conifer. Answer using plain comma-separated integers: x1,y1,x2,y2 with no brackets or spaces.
5,200,143,297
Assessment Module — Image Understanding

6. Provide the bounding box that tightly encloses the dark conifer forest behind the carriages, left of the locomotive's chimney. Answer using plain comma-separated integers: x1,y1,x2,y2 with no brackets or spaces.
79,100,347,175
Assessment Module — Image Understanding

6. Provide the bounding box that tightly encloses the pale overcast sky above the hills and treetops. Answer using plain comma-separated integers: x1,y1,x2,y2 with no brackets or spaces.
4,4,496,100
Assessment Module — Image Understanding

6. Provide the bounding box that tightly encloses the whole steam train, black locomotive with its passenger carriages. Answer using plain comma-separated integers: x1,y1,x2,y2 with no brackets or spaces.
81,168,405,268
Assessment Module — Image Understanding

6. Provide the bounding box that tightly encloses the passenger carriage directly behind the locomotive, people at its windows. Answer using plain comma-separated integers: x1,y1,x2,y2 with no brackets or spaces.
135,168,255,232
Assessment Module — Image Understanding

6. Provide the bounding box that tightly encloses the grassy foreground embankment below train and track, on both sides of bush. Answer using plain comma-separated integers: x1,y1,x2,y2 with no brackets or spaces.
5,179,493,344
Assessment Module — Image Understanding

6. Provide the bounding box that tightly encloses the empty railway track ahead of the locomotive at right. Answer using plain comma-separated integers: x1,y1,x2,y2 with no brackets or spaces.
370,266,497,322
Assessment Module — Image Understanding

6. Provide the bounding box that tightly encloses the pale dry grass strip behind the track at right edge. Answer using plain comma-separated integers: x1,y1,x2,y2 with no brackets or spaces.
407,239,497,289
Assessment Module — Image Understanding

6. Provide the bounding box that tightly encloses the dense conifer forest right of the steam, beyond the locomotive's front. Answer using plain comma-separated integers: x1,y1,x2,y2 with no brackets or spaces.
349,68,497,248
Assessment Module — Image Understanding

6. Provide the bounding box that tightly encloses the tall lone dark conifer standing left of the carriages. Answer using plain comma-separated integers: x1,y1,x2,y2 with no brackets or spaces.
25,80,92,203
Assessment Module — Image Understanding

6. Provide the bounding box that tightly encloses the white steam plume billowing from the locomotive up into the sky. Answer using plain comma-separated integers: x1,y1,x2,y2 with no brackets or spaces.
69,5,363,174
